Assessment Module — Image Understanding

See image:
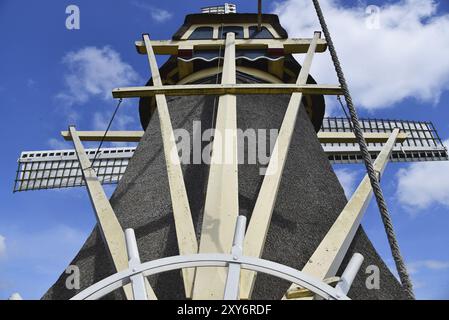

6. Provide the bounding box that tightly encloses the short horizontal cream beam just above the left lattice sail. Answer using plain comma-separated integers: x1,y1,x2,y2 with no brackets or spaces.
61,131,144,142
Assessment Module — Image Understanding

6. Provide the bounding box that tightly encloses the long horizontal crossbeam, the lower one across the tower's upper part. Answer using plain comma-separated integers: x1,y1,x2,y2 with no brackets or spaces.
112,83,343,98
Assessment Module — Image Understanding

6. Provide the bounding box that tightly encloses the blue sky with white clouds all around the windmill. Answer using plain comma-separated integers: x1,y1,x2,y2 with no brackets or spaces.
0,0,449,299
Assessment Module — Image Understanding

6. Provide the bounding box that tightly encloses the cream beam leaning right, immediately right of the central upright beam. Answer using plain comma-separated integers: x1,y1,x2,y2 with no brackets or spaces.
240,32,321,299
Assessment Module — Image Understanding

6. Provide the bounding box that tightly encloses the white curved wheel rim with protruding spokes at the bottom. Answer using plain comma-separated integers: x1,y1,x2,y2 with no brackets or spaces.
70,216,363,300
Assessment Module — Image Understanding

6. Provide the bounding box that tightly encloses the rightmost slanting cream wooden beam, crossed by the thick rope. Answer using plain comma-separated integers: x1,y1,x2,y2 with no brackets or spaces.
284,129,399,299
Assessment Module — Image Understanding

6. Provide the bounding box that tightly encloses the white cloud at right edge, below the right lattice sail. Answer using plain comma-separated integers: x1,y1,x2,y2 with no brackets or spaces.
396,140,449,213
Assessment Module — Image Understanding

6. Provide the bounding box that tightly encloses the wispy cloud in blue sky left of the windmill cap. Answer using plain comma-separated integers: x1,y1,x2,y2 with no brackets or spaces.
57,46,140,106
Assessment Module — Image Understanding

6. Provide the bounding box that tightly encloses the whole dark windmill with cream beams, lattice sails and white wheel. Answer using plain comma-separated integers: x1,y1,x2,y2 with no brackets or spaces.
15,5,448,299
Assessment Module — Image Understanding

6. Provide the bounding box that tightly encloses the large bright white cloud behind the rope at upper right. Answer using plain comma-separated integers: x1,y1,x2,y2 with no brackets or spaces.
275,0,449,109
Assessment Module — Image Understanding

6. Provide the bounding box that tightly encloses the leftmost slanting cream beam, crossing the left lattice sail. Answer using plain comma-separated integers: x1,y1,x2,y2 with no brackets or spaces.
69,126,156,300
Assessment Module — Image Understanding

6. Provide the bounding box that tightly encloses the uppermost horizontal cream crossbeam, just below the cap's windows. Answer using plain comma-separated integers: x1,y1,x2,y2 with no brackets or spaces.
135,39,327,55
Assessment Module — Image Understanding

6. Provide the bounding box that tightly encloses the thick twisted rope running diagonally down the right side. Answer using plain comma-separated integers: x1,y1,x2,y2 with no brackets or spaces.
312,0,415,299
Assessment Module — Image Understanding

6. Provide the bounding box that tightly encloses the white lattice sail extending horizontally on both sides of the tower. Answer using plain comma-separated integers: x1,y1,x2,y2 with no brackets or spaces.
14,118,448,192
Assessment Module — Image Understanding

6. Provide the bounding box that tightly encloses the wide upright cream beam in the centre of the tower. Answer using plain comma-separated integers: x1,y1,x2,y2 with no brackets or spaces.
193,33,239,299
